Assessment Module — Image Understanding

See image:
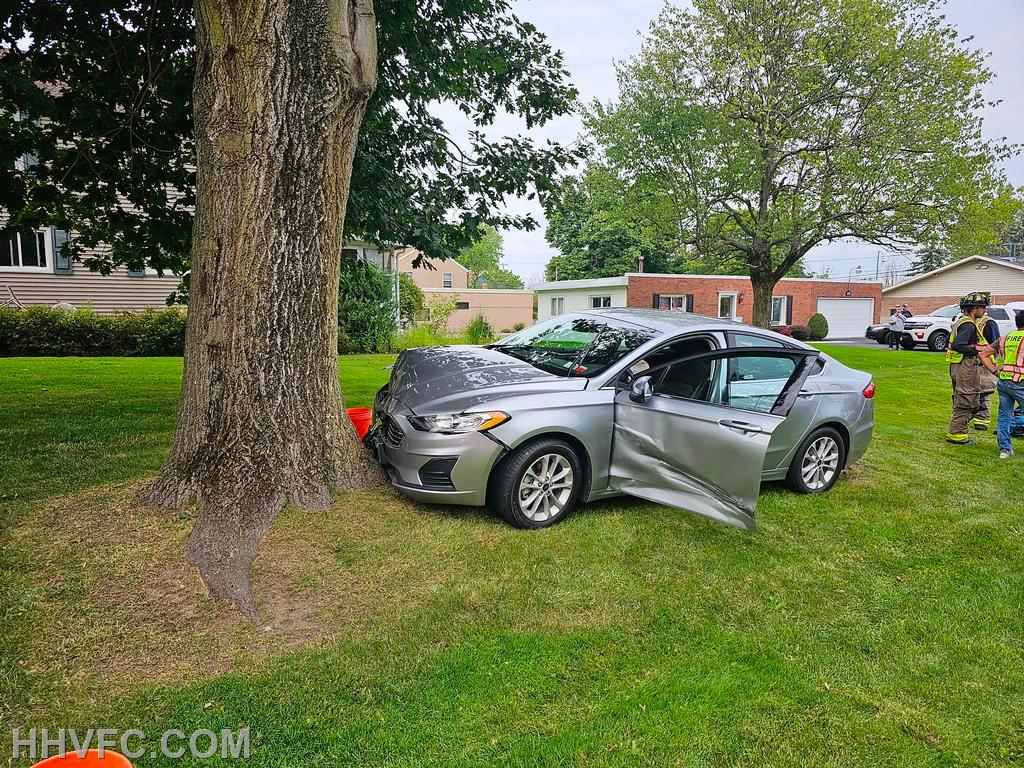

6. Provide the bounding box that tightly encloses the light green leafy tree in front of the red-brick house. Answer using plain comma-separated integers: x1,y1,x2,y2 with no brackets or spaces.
587,0,1009,325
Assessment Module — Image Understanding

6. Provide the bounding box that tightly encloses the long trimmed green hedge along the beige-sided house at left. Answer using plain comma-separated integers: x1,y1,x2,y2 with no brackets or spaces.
0,306,185,357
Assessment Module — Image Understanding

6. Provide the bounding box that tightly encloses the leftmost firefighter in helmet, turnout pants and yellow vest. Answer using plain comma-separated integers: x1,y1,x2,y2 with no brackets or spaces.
946,293,988,445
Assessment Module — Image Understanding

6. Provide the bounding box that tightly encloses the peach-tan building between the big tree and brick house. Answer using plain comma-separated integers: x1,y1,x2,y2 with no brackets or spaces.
395,248,534,331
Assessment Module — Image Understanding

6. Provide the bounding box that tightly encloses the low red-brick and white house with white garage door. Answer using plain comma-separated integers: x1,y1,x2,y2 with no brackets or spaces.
534,272,882,339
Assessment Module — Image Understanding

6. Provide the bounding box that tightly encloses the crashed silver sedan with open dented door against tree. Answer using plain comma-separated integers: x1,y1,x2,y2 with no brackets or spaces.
367,308,874,529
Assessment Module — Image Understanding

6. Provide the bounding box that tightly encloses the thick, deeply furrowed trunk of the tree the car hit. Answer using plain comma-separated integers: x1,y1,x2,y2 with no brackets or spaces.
146,0,379,621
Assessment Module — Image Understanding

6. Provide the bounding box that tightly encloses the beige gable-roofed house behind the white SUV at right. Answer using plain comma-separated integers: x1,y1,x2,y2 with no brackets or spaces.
882,256,1024,315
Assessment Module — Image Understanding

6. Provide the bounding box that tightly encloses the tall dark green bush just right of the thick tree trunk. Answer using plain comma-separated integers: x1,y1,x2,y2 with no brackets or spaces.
338,260,395,354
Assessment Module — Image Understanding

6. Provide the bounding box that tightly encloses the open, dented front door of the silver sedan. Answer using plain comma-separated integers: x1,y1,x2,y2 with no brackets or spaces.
609,347,818,530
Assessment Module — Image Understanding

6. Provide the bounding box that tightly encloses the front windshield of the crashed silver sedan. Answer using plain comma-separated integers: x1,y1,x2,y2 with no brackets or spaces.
490,315,655,378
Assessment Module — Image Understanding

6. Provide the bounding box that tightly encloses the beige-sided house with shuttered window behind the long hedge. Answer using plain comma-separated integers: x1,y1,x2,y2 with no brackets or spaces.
0,227,391,314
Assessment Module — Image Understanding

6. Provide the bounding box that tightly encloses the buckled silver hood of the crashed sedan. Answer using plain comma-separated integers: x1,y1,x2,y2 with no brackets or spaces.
387,346,587,413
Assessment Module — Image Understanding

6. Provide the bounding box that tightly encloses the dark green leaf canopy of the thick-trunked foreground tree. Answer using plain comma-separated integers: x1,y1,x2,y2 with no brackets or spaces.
0,0,575,282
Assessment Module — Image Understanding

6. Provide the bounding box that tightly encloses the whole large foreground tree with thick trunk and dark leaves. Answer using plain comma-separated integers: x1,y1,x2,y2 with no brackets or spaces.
0,0,572,618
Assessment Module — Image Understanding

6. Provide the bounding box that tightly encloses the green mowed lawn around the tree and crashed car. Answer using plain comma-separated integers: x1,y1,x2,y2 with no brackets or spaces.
0,347,1024,766
